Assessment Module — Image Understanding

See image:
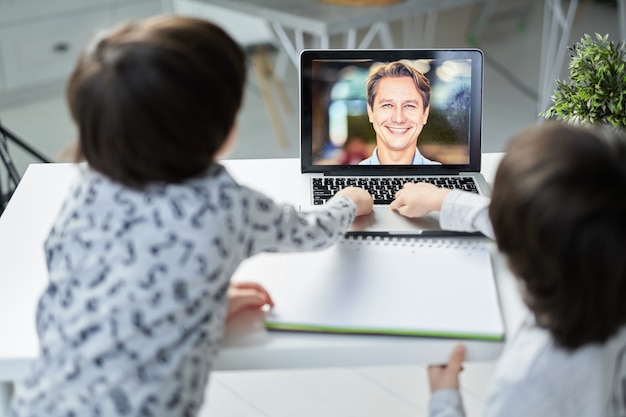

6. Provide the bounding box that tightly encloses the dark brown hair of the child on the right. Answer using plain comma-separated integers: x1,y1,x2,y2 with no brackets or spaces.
489,122,626,349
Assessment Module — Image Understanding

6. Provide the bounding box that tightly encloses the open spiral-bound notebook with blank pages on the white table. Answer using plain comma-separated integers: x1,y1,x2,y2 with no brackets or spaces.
266,239,505,341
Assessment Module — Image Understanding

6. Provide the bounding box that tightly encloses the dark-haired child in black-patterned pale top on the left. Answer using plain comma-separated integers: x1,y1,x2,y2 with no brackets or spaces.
11,16,372,417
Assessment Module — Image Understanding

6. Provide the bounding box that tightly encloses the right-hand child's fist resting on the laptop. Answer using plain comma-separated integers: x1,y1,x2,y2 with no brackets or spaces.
389,182,450,217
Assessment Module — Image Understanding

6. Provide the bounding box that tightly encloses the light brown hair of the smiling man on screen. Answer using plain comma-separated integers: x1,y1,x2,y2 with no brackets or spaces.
366,60,431,110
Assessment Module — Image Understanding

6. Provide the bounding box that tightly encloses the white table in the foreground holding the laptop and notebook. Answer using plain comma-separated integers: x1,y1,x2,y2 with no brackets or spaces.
0,154,525,416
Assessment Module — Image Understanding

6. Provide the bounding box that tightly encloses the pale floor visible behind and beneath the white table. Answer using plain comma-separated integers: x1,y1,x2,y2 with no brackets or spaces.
0,0,617,417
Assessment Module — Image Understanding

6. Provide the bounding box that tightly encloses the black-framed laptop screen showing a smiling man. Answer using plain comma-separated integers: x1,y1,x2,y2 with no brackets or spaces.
300,49,483,174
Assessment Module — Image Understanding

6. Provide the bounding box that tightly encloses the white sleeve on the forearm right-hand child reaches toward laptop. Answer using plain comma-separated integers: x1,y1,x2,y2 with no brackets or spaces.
439,190,494,239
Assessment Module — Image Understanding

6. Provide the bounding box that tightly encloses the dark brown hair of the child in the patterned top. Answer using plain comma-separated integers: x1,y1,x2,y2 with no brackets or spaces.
66,16,246,188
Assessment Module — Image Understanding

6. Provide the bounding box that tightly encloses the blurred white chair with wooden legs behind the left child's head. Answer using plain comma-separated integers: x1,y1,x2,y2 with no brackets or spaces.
163,0,292,148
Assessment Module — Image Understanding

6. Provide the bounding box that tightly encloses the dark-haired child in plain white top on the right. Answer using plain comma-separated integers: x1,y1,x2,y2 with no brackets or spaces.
392,122,626,417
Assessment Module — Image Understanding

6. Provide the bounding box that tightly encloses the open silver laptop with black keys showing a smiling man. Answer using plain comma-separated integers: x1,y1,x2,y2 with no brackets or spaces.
300,49,490,236
